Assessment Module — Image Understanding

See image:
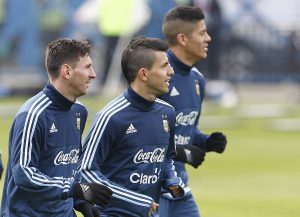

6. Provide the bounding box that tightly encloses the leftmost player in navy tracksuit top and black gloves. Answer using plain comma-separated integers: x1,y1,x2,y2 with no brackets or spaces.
1,39,112,217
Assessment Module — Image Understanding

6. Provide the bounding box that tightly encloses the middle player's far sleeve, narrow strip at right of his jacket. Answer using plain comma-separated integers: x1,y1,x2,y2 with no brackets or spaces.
161,113,184,191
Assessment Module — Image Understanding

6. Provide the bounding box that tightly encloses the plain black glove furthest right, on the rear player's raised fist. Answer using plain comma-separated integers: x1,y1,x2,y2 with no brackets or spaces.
205,132,227,153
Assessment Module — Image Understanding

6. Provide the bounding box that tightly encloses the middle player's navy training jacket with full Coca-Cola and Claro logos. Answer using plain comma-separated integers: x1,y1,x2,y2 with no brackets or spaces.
81,88,183,217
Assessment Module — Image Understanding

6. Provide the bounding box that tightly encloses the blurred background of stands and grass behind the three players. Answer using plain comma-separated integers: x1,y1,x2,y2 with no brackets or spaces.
0,0,300,217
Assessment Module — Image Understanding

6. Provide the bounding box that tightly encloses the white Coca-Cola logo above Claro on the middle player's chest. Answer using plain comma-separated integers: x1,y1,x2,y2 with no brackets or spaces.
133,148,165,164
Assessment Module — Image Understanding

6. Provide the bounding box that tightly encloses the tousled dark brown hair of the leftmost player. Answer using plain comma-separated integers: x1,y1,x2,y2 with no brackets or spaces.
45,38,91,78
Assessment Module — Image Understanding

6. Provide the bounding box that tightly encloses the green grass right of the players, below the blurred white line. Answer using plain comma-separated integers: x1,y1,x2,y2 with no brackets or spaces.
189,128,300,217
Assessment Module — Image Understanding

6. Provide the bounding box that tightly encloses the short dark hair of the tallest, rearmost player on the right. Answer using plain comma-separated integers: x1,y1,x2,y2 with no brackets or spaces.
162,6,204,46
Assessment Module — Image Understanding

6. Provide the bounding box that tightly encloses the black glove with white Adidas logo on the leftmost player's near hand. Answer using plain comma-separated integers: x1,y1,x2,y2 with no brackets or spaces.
72,182,113,206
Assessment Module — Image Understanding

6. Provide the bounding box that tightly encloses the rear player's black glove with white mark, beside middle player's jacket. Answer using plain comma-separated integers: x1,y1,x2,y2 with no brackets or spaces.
175,145,205,168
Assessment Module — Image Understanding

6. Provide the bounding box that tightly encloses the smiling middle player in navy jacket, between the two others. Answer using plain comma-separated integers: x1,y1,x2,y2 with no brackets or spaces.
81,36,184,217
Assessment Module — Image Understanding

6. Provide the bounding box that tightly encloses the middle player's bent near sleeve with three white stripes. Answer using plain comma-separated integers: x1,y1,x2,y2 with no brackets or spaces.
80,113,153,216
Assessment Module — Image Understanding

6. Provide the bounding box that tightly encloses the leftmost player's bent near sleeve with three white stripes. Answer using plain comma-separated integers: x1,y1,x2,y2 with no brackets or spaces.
10,112,72,200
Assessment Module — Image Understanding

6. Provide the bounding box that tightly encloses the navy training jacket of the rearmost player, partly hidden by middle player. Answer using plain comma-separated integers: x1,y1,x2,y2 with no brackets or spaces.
161,50,208,199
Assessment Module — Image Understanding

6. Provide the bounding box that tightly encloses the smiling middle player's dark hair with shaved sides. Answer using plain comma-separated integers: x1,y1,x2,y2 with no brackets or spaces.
121,36,168,84
